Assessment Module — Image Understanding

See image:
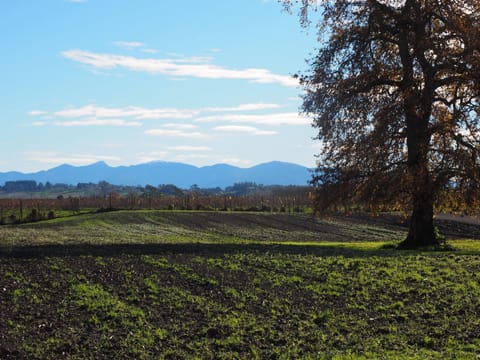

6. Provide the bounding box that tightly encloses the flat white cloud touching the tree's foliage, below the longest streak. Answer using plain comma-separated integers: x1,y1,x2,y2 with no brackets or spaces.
195,112,312,125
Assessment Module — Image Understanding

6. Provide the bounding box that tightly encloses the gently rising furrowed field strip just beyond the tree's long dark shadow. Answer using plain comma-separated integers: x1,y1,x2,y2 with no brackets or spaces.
0,211,405,247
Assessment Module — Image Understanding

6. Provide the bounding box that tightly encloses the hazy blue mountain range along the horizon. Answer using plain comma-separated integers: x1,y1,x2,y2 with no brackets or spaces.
0,161,311,189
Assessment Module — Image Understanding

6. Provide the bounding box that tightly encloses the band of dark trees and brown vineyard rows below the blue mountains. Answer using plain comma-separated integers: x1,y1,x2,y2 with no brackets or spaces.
0,180,312,225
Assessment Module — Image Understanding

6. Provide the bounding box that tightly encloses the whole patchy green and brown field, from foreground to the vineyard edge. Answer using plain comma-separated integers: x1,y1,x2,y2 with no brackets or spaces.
0,211,480,359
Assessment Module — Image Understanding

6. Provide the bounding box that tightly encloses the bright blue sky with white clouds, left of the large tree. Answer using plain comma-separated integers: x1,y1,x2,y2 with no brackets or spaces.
0,0,318,172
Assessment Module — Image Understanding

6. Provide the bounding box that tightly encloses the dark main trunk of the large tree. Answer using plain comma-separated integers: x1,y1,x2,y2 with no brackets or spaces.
398,1,439,249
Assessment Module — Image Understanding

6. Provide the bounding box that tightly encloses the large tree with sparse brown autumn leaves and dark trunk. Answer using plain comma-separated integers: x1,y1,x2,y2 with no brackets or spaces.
283,0,480,248
